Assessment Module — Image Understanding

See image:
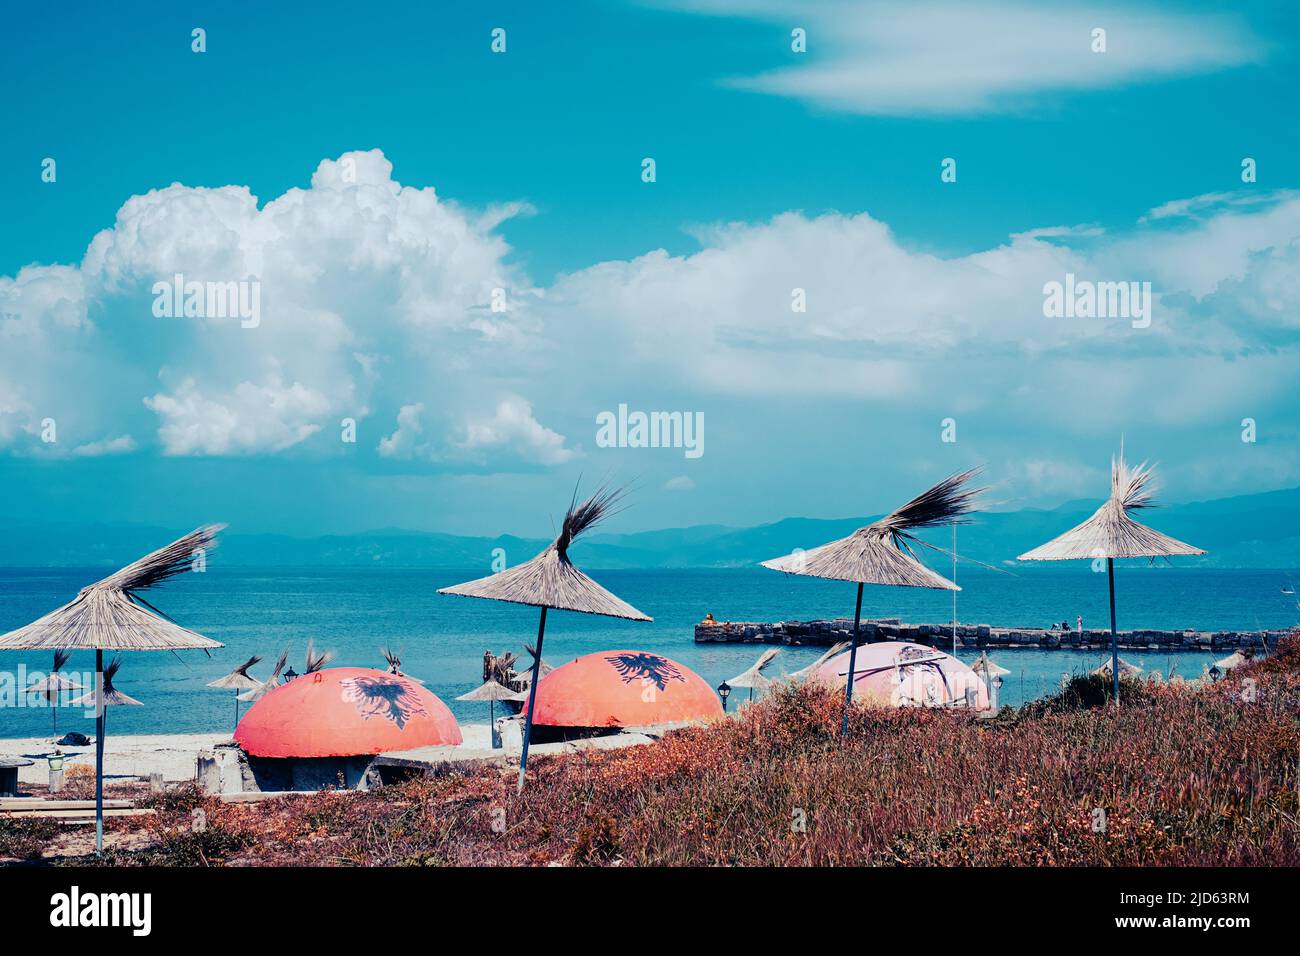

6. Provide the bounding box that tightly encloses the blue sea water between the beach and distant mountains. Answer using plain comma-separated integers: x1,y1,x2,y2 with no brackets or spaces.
0,562,1300,737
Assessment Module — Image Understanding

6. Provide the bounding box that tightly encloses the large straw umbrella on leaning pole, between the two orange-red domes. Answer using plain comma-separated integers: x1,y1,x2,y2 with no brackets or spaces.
438,488,653,792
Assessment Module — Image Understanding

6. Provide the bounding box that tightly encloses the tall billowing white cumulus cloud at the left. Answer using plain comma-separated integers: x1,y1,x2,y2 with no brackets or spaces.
0,150,548,465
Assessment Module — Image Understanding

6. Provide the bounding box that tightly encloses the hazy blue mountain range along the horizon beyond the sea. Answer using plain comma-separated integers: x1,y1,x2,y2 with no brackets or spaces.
0,488,1300,570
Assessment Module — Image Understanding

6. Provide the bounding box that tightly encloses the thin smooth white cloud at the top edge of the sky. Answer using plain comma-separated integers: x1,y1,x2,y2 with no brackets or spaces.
655,0,1266,116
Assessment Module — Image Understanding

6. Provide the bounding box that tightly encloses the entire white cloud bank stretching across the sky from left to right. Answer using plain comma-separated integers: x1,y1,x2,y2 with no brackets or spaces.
0,151,1300,496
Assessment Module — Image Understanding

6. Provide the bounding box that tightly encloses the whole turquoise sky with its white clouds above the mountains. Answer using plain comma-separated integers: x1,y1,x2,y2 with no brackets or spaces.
0,0,1300,536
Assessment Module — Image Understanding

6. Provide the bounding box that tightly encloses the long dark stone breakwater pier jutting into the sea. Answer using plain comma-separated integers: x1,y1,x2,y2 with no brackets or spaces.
696,618,1290,650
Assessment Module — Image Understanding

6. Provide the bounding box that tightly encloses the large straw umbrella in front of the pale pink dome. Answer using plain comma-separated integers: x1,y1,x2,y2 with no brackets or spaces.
763,470,983,736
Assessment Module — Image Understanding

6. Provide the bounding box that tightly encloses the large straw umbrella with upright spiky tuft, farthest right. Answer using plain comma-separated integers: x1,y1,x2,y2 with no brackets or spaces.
1017,441,1205,708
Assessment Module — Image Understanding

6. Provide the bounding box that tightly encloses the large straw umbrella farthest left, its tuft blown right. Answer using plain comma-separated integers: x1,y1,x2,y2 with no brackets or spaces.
0,525,221,851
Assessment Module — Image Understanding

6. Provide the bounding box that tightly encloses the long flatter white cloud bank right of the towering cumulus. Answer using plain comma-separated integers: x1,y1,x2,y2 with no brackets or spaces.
543,194,1300,493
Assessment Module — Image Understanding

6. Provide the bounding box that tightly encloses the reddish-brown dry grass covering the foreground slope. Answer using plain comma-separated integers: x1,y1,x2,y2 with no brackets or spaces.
45,639,1300,866
